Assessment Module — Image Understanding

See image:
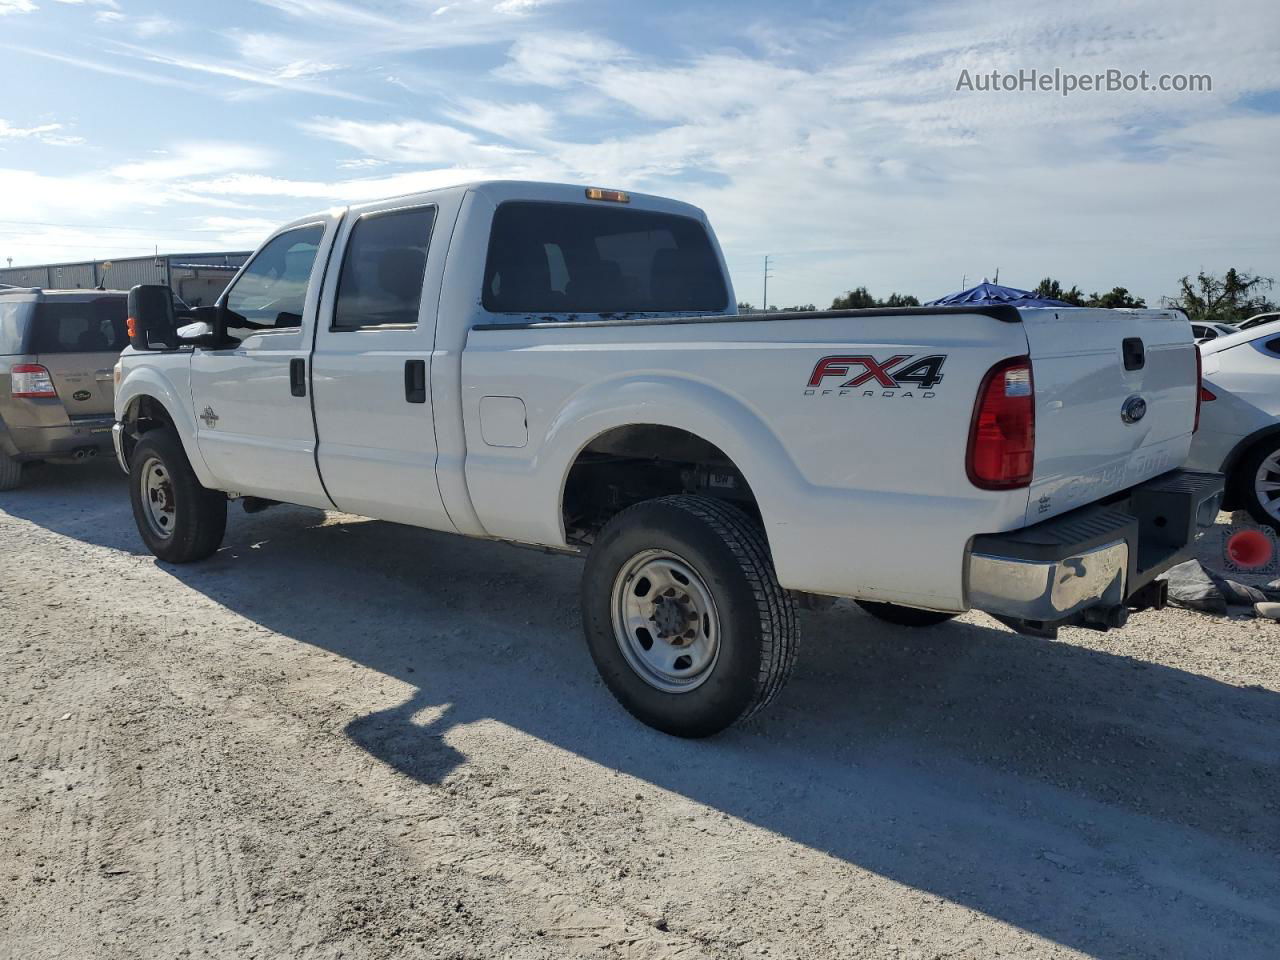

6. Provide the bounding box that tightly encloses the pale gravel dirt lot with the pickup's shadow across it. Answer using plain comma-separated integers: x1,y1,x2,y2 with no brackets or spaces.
0,465,1280,960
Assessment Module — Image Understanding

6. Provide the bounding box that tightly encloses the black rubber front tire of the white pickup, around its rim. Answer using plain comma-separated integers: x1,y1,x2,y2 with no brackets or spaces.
129,429,227,563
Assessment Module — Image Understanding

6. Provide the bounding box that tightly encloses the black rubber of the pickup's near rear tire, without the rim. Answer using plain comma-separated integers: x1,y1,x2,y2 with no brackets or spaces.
582,497,799,737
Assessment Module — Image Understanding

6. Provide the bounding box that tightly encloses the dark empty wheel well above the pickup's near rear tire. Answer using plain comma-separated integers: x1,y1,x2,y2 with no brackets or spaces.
561,424,760,545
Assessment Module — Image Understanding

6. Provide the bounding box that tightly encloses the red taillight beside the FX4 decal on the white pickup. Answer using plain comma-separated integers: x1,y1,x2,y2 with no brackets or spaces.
965,357,1036,490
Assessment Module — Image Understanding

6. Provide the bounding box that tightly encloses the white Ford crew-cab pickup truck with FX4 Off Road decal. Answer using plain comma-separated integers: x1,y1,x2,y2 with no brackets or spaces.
114,182,1221,736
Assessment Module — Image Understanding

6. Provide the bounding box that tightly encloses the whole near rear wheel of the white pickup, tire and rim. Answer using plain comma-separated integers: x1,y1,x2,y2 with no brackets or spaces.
582,495,799,737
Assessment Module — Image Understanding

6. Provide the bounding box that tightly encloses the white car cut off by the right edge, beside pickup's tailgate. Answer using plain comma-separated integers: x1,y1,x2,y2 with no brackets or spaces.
1187,324,1280,531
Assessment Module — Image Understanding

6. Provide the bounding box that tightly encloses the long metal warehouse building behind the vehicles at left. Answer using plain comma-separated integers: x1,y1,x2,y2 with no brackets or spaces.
0,251,250,307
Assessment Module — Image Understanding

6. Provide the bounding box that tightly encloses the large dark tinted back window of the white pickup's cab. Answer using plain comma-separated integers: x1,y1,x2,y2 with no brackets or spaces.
483,202,728,314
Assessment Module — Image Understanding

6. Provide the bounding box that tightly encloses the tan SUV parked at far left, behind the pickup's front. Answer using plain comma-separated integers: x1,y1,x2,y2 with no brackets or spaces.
0,287,129,490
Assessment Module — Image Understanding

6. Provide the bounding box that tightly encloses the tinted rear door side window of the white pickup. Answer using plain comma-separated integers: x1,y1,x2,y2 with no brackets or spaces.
332,206,435,330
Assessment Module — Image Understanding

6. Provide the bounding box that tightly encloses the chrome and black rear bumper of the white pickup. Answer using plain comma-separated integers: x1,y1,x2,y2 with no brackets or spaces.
966,470,1222,632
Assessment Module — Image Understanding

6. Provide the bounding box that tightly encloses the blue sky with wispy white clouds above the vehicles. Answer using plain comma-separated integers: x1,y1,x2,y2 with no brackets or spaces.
0,0,1280,306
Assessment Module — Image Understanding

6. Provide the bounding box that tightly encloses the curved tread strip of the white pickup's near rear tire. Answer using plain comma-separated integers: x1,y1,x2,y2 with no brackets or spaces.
586,494,799,727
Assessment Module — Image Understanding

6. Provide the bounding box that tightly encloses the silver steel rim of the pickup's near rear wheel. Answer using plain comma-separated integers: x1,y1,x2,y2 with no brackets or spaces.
612,550,721,694
